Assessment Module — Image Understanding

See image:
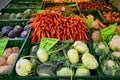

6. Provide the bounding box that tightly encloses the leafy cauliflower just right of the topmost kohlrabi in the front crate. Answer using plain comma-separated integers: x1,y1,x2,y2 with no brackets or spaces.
94,42,110,56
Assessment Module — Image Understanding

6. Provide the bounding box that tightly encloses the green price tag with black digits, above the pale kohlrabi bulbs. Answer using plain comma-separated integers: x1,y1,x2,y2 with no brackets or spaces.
40,37,59,51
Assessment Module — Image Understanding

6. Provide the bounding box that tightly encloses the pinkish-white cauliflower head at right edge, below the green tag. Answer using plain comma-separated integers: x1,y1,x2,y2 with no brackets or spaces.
109,35,120,51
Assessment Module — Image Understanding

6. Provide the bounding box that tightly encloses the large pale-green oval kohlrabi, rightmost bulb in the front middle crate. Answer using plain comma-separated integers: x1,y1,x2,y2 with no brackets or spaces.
82,52,98,69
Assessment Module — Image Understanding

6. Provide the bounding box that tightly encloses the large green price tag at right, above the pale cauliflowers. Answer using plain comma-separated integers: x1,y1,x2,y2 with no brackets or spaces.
101,23,117,43
